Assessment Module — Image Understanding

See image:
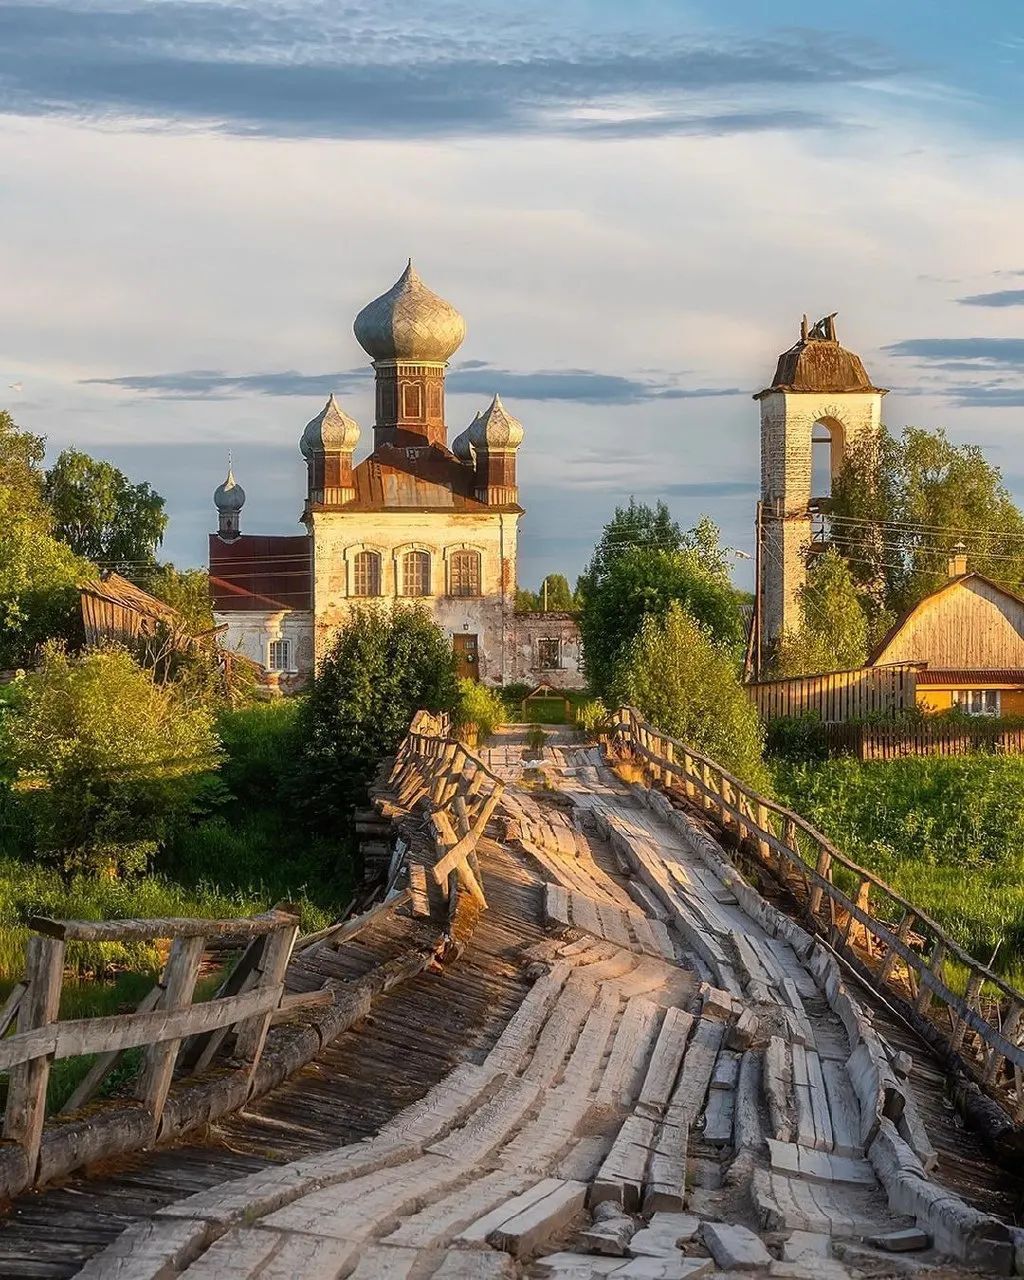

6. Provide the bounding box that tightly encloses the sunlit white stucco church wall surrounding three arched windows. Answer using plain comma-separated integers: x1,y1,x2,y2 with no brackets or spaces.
311,511,518,684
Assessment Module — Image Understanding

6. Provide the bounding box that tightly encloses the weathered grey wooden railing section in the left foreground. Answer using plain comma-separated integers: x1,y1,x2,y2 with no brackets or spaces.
0,909,298,1184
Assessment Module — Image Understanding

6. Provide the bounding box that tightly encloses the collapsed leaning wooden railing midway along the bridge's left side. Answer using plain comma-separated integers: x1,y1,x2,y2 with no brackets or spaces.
388,712,504,918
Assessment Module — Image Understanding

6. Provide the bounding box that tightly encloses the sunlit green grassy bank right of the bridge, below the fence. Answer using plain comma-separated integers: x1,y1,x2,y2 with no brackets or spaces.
774,755,1024,987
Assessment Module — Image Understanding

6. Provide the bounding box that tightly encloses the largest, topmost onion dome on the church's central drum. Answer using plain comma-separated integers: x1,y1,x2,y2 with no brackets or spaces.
352,259,466,364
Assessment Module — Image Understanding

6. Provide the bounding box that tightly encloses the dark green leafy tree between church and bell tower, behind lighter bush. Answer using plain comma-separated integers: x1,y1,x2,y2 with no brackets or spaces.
580,504,744,701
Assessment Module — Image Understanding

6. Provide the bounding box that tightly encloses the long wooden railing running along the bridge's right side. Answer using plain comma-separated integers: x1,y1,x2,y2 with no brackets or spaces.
612,707,1024,1124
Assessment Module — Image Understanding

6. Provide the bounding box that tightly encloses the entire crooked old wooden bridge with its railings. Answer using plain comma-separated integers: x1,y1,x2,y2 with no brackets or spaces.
0,709,1024,1280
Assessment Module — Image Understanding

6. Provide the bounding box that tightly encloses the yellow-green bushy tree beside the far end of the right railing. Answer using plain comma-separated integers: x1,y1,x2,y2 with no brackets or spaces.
614,602,767,787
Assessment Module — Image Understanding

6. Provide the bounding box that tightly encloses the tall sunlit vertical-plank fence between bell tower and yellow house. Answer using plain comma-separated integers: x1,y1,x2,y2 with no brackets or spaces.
746,663,918,724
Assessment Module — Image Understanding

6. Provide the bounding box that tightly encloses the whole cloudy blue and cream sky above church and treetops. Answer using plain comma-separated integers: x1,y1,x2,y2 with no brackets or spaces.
0,0,1024,586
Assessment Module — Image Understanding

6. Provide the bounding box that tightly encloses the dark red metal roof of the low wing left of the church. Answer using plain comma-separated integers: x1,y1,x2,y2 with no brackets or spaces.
210,534,312,613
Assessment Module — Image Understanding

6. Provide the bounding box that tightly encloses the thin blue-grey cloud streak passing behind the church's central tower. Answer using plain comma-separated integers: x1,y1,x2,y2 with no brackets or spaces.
83,360,745,404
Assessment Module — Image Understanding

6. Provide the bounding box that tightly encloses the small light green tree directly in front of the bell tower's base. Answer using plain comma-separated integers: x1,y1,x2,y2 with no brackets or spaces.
774,548,868,676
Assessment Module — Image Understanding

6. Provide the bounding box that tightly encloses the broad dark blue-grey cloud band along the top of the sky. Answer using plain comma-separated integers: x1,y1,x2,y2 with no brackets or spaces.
0,0,906,140
